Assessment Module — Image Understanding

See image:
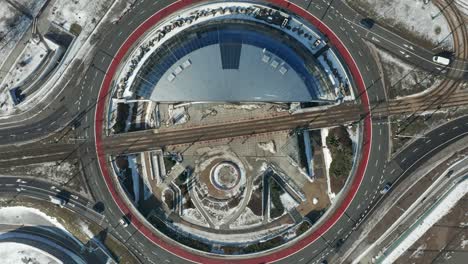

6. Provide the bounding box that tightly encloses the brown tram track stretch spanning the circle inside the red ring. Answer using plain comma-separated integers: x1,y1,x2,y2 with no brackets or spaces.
103,102,366,154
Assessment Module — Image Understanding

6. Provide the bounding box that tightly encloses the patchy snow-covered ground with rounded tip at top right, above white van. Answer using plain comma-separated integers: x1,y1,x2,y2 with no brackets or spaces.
346,0,454,48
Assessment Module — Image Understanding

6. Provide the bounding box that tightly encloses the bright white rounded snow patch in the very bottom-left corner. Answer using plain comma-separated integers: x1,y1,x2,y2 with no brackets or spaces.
0,242,63,264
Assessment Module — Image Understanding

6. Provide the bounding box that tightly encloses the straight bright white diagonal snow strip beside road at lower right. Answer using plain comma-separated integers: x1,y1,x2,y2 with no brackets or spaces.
381,180,468,264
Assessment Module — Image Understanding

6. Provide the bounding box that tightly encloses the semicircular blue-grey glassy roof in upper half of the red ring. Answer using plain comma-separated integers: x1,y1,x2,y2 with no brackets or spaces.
137,21,326,102
